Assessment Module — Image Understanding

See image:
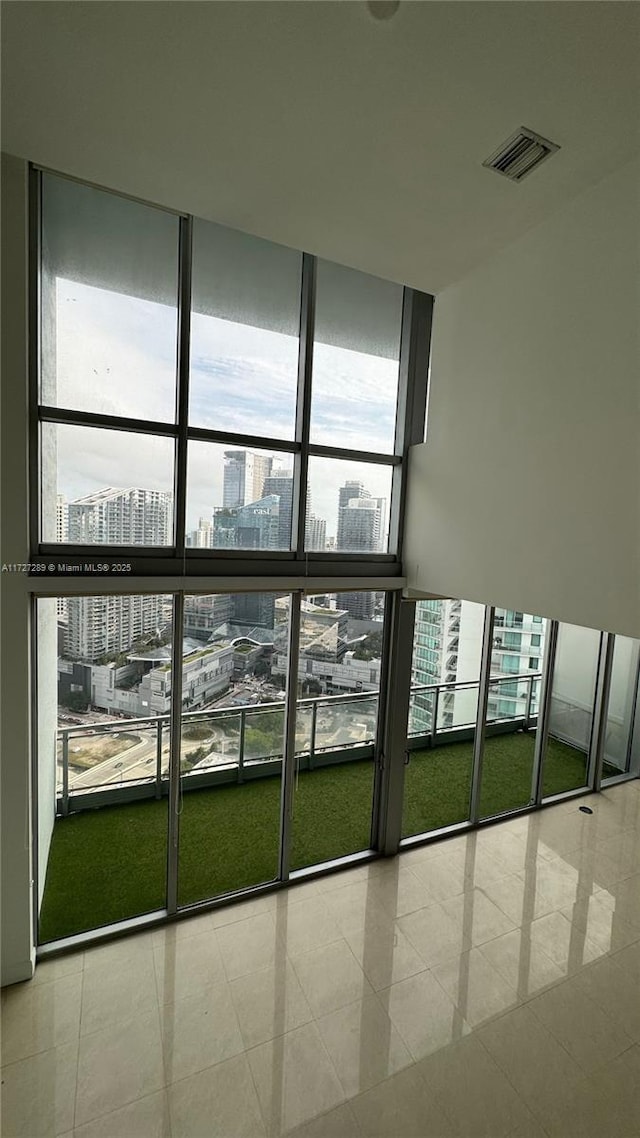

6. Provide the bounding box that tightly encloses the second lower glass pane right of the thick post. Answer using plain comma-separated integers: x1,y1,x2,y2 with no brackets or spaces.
479,609,547,818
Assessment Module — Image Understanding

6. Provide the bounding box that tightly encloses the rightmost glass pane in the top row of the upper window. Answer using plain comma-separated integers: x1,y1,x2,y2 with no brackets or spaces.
311,261,403,454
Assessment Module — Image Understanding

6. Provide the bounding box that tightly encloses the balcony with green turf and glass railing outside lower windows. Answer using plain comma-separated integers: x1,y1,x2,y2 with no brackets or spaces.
40,676,614,941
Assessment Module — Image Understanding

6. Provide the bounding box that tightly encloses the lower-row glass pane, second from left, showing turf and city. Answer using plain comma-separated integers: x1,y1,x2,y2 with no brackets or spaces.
178,593,290,905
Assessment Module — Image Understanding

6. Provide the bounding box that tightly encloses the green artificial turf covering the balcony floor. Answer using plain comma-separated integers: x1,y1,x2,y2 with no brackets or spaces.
40,733,607,942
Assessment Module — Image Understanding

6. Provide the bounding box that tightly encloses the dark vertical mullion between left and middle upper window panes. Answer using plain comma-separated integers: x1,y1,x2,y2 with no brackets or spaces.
173,217,192,556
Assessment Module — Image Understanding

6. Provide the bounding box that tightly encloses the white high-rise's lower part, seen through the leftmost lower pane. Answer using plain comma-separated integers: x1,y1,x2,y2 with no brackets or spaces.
65,594,163,663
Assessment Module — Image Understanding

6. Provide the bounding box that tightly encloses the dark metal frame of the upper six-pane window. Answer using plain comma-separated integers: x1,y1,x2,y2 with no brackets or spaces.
30,166,434,578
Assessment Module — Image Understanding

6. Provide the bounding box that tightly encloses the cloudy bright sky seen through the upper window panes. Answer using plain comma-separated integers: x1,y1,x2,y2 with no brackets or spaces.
52,278,397,535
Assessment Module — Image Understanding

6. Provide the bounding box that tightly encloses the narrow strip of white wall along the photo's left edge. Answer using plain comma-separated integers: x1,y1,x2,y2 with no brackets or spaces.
0,155,35,984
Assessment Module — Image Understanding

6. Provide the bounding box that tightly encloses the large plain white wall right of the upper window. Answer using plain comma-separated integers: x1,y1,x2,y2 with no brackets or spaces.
404,163,640,636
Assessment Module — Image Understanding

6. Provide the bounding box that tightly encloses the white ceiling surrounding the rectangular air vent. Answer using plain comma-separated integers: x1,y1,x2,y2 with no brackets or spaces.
2,0,640,291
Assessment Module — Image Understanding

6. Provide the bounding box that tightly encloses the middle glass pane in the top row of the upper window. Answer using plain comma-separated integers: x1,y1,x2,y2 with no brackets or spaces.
189,220,302,439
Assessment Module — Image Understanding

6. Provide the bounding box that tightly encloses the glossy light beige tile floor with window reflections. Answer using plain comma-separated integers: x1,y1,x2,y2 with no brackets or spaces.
1,781,640,1138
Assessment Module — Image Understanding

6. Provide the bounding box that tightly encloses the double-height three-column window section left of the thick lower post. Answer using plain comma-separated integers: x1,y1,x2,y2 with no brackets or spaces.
31,171,432,941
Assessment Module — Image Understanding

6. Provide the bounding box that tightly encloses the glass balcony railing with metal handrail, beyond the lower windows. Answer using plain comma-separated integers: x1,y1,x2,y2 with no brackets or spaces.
57,673,540,815
